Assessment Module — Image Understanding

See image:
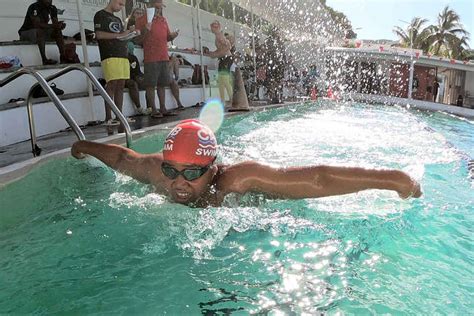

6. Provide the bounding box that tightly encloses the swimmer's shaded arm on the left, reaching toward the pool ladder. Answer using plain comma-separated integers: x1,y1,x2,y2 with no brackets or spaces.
71,140,162,183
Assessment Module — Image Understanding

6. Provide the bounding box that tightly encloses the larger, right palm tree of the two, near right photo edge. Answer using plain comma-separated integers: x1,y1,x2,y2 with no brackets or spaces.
428,6,469,57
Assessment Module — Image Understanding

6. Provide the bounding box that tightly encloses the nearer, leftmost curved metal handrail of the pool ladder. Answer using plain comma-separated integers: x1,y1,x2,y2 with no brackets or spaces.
0,68,86,157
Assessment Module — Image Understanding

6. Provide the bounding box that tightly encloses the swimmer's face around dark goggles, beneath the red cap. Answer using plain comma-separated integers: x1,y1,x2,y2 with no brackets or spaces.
161,161,217,204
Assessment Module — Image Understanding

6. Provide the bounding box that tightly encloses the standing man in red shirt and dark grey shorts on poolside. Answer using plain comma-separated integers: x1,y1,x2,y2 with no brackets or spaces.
136,0,178,118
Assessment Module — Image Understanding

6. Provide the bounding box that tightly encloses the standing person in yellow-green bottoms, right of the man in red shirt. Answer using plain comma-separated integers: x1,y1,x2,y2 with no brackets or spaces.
208,21,234,104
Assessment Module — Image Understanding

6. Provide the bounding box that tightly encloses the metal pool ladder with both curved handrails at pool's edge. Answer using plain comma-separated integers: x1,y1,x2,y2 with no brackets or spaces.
0,64,132,157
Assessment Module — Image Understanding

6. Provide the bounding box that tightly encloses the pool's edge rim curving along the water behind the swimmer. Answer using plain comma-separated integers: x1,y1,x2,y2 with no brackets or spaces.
0,94,474,187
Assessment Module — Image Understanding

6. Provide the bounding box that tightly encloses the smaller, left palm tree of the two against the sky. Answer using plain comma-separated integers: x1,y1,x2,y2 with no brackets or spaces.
393,17,429,51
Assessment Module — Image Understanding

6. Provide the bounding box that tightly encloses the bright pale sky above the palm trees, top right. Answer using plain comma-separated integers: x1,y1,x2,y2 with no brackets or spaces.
326,0,474,49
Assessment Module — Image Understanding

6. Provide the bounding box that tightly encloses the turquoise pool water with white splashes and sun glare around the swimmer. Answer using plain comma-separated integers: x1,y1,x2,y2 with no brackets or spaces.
0,103,474,315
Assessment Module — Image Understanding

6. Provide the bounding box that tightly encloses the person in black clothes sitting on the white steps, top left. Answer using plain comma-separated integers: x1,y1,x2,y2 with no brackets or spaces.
18,0,66,65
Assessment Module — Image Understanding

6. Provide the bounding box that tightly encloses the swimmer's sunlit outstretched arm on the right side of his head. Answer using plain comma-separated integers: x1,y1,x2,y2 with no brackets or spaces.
224,162,421,199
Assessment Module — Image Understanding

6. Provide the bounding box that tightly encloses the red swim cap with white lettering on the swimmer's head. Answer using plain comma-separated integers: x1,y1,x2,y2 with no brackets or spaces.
163,120,217,166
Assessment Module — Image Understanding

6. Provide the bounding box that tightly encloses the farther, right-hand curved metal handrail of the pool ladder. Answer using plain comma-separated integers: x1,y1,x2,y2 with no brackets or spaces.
27,64,132,148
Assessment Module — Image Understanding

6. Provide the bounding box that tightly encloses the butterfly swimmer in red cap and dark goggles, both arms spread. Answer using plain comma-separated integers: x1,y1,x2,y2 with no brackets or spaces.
71,119,421,207
